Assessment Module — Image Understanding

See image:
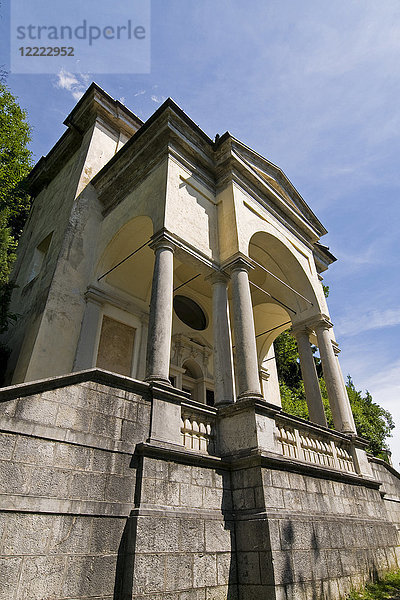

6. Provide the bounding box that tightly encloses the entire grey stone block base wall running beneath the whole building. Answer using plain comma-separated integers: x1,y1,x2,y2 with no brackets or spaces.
0,370,400,600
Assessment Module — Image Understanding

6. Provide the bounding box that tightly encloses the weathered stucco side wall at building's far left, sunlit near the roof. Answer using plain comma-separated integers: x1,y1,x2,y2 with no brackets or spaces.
4,120,129,383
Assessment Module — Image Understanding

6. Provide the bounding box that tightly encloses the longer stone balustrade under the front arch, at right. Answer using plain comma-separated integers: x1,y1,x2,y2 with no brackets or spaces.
276,421,356,473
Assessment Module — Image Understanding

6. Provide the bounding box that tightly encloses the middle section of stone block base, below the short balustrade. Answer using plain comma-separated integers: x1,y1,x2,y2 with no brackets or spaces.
118,447,237,600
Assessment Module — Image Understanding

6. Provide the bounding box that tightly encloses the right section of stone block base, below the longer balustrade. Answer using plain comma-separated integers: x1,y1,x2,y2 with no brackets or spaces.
232,458,400,600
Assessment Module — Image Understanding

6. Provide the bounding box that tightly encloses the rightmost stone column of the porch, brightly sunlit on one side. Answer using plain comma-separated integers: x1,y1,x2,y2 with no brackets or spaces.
314,319,356,433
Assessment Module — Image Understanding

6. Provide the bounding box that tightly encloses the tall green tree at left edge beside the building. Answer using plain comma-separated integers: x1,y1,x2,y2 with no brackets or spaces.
0,83,32,332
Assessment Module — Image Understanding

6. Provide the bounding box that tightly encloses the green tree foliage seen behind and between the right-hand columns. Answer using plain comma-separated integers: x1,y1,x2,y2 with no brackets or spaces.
274,332,394,460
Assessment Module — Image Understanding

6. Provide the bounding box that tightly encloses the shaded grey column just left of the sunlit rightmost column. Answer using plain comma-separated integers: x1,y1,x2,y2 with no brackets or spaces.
293,327,328,427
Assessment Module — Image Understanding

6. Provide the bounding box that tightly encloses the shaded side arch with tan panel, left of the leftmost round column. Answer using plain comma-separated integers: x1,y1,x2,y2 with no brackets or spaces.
74,216,154,378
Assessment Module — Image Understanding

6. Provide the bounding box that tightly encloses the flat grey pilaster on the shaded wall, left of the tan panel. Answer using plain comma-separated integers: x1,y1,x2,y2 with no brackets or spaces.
73,292,103,371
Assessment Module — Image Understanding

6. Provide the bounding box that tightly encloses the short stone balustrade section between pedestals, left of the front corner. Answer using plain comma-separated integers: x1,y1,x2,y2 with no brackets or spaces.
181,406,216,454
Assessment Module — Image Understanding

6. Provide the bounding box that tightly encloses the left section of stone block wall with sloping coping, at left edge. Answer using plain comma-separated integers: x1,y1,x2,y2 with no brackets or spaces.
0,370,150,600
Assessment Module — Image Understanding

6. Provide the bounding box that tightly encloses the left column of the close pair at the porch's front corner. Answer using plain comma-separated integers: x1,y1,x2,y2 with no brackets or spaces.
210,273,235,406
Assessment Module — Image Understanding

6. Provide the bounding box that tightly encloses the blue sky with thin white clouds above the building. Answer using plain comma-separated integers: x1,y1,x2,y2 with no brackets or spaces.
0,0,400,466
